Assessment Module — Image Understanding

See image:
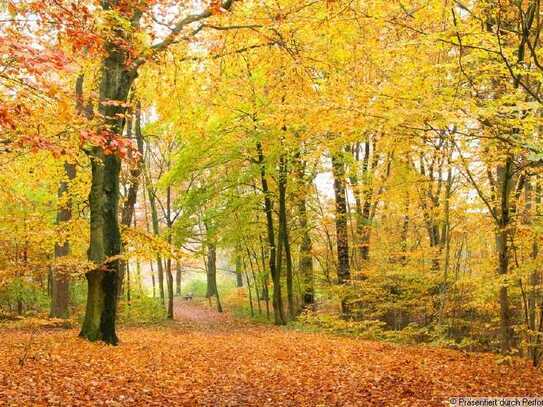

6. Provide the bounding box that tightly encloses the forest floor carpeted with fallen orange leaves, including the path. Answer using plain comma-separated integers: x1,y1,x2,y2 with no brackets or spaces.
0,300,543,406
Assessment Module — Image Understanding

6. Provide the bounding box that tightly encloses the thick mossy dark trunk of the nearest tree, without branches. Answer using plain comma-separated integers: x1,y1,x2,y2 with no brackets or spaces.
80,40,136,344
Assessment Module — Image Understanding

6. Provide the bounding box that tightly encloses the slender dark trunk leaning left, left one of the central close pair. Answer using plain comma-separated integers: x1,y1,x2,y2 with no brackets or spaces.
256,141,286,325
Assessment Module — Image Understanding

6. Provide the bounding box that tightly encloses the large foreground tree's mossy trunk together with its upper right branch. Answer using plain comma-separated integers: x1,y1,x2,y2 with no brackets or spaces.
80,0,238,344
